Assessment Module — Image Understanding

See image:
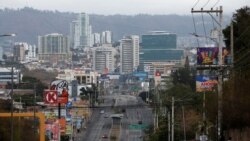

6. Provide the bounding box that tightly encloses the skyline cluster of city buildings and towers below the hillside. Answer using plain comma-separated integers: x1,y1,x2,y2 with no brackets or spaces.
0,13,184,91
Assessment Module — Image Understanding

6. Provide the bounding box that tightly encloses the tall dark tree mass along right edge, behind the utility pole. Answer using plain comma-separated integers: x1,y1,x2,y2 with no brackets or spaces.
222,6,250,140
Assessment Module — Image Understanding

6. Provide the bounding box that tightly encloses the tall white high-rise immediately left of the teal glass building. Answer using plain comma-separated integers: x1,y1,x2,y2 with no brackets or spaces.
120,35,139,73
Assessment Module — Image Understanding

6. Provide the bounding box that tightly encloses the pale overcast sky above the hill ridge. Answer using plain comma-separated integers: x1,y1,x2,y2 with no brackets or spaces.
0,0,250,15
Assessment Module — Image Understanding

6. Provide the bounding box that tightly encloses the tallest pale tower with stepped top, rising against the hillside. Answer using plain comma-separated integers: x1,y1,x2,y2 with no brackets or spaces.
70,13,92,48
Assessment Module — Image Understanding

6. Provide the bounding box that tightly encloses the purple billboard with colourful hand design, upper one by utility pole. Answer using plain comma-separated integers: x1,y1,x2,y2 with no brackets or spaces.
197,47,231,65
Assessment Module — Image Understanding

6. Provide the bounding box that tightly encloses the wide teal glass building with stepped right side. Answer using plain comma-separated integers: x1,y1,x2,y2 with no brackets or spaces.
140,31,184,74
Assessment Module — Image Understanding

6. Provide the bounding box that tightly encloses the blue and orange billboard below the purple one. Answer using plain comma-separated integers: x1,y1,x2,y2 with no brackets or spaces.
196,75,218,92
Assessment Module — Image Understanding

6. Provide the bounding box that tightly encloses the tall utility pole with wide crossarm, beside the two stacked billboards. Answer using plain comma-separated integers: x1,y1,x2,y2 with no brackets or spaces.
191,6,224,140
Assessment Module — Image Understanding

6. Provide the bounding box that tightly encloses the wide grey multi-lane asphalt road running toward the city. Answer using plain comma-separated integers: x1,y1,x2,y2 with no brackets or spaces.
76,93,153,141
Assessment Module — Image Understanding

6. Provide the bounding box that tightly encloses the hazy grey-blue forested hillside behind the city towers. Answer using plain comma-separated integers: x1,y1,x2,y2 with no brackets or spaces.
0,7,229,44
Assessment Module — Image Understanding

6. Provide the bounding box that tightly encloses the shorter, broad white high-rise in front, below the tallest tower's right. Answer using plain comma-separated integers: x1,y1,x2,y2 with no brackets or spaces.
92,44,116,74
